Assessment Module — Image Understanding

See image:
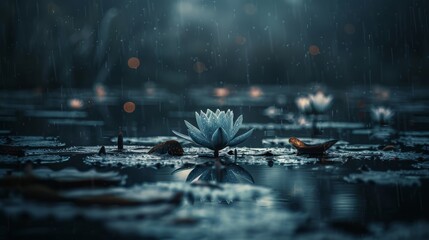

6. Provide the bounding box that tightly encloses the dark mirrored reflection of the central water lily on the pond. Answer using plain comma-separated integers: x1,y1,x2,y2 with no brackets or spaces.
173,160,255,183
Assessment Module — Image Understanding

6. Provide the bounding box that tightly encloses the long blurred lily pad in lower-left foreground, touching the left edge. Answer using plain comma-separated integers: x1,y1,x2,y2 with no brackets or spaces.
0,186,182,223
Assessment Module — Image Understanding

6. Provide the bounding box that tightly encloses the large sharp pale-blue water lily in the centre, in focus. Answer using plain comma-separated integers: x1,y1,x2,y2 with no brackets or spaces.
173,109,253,157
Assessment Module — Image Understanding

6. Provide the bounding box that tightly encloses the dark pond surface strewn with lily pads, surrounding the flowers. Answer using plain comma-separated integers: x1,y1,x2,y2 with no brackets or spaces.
0,86,429,239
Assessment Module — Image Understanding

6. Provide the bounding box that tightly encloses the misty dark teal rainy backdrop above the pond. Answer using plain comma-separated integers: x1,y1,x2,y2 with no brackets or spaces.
0,0,429,92
